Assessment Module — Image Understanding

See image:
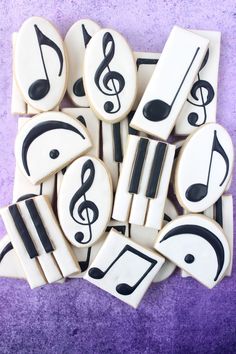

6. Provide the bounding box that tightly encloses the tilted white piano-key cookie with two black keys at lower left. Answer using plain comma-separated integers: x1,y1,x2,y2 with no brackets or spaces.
1,196,80,288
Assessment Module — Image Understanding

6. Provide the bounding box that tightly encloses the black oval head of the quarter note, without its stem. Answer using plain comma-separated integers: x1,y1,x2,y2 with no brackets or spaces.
143,100,171,122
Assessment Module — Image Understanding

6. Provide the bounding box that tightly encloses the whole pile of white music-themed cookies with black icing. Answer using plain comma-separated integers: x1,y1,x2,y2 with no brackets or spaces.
0,17,234,307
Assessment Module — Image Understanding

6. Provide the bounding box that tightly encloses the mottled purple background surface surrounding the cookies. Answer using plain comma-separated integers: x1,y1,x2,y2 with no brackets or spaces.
0,0,236,354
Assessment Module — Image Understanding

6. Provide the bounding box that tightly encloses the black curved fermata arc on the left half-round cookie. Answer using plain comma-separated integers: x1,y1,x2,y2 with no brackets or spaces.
22,120,85,176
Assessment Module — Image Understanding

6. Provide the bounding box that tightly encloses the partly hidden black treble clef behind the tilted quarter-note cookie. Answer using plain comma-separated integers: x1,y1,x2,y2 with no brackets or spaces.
187,49,215,127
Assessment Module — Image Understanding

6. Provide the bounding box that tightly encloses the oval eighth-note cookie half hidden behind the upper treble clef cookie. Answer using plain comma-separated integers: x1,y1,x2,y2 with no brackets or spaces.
64,19,101,107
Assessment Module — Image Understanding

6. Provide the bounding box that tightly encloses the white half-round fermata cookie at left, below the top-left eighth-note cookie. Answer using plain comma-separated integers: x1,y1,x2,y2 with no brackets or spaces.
15,112,91,184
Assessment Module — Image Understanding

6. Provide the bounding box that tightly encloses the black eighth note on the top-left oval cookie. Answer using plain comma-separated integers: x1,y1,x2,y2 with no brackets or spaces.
28,25,63,101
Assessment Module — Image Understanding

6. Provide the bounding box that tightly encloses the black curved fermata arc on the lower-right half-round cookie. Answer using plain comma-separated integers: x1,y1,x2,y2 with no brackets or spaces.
160,225,225,281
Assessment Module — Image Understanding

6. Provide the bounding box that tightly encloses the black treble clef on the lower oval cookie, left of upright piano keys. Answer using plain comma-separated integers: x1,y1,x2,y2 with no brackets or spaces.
69,160,99,244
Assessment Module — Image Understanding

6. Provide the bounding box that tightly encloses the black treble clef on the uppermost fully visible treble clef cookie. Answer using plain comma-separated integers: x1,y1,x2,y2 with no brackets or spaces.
94,32,125,114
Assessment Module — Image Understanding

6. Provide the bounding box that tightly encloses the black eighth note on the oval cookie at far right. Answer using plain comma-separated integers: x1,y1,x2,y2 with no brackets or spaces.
185,130,229,202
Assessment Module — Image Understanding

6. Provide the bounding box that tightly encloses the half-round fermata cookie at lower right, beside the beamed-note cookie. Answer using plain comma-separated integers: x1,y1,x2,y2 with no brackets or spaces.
155,214,230,289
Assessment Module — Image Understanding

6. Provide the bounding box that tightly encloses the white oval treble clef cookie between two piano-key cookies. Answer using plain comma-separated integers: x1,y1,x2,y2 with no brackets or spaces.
58,156,113,247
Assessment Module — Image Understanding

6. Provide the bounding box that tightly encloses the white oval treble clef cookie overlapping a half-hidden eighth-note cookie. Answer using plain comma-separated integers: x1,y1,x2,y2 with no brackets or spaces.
84,29,137,123
